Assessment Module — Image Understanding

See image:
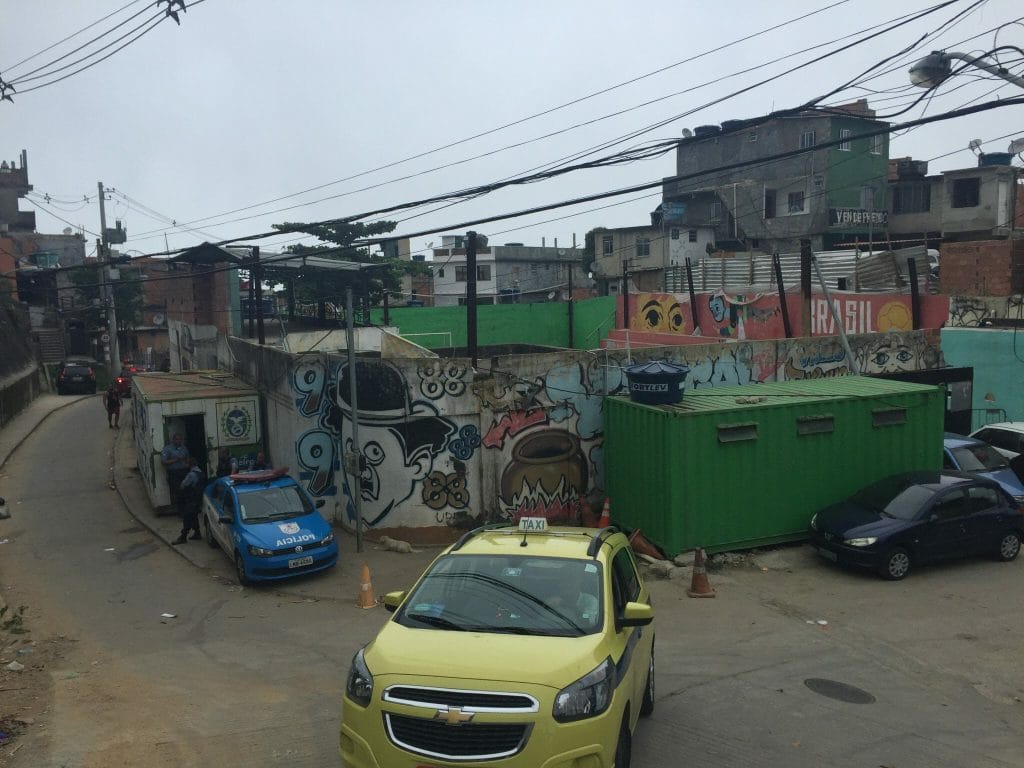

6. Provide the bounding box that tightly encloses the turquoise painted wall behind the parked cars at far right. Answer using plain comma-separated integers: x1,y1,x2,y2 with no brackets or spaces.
940,328,1024,428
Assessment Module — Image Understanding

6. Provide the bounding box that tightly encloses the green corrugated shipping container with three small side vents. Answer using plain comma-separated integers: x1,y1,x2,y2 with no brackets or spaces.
604,376,945,556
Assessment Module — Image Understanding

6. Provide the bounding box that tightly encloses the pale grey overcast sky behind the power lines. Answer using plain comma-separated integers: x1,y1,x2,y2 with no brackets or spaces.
0,0,1024,258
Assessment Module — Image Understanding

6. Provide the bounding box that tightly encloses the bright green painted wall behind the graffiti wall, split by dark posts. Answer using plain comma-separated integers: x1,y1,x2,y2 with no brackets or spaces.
371,296,615,349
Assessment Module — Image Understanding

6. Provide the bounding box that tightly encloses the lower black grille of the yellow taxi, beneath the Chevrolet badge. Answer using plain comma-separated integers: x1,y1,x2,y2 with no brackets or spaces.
384,713,529,760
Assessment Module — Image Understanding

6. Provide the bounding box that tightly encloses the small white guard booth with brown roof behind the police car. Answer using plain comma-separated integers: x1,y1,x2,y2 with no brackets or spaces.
131,371,262,513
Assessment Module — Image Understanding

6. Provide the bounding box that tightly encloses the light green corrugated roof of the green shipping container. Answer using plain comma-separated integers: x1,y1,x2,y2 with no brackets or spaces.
624,376,936,416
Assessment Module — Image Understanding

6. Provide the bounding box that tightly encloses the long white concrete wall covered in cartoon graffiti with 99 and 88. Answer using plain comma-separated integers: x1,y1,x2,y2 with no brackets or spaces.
229,332,941,542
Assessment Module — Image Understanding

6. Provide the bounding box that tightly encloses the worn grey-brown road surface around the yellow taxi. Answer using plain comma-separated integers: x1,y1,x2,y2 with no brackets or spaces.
0,399,1024,768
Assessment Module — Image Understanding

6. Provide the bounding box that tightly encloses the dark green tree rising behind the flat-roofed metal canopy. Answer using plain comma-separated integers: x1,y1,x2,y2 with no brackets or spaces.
271,221,426,304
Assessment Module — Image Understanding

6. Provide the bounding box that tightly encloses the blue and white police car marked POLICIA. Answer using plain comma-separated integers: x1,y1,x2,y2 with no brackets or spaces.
202,467,338,586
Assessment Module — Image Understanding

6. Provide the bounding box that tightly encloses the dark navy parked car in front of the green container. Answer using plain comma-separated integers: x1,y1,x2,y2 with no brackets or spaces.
810,470,1024,580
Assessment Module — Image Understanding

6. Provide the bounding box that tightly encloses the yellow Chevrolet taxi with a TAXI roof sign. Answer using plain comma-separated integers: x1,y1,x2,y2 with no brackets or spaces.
340,518,654,768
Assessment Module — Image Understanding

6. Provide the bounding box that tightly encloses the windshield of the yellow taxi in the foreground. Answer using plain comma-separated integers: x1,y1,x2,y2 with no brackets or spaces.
394,554,603,637
